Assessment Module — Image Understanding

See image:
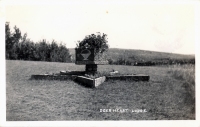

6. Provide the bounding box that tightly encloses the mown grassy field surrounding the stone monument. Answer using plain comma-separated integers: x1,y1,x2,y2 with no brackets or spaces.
6,60,195,121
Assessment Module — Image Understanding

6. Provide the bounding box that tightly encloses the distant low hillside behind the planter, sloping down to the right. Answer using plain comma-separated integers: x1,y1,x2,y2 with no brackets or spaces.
69,48,195,65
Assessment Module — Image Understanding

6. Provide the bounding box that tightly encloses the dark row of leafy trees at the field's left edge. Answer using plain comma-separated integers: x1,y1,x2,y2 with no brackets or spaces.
5,22,71,62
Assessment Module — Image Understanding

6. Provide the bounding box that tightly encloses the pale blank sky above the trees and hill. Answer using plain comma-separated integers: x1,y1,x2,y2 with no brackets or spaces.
5,0,196,54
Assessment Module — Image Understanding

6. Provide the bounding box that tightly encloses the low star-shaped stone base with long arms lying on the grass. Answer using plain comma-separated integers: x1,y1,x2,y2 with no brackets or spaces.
31,71,150,88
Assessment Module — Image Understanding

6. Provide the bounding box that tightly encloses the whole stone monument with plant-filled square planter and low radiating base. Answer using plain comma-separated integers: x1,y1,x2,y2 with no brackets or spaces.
31,34,150,87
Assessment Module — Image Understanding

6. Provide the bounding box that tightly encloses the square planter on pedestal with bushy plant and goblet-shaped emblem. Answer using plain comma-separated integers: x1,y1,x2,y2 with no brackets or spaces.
75,33,109,75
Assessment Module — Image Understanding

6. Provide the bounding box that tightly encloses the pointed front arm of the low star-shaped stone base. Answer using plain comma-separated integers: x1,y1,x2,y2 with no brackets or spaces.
76,76,106,88
